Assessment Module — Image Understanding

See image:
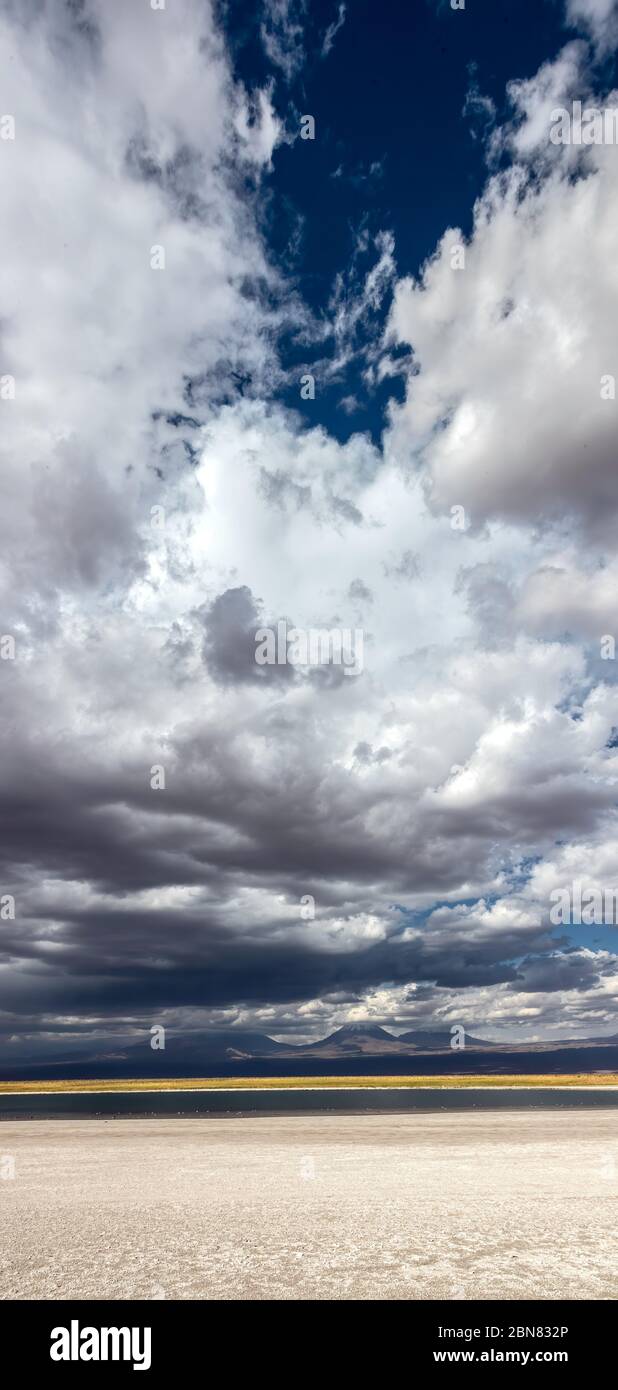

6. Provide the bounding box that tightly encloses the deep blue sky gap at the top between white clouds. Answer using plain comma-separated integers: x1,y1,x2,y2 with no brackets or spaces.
221,0,615,439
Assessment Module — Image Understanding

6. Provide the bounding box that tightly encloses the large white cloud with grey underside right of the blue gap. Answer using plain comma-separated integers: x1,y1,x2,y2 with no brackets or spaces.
387,44,618,539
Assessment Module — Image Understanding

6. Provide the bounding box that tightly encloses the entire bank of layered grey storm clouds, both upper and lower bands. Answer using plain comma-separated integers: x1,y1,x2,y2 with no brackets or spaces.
0,558,612,1056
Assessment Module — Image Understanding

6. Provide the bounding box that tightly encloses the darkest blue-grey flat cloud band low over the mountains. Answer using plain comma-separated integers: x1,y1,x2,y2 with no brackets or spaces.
3,889,530,1016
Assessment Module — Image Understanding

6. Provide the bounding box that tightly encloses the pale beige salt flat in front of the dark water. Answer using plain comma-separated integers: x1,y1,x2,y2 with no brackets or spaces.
0,1111,618,1300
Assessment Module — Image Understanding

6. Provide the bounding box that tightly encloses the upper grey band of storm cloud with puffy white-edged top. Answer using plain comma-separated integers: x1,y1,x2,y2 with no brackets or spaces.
0,700,611,895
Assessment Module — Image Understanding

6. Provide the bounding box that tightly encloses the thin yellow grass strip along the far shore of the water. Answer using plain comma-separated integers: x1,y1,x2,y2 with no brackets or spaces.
0,1072,618,1095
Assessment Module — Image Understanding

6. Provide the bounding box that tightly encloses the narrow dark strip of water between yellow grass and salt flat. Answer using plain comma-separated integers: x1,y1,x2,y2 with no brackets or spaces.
0,1087,618,1120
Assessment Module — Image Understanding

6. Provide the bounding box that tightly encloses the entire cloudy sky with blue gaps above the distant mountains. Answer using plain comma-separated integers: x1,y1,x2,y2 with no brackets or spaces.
0,0,618,1065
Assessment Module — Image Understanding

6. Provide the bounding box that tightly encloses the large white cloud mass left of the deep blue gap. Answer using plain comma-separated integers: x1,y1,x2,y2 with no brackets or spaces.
0,0,276,625
